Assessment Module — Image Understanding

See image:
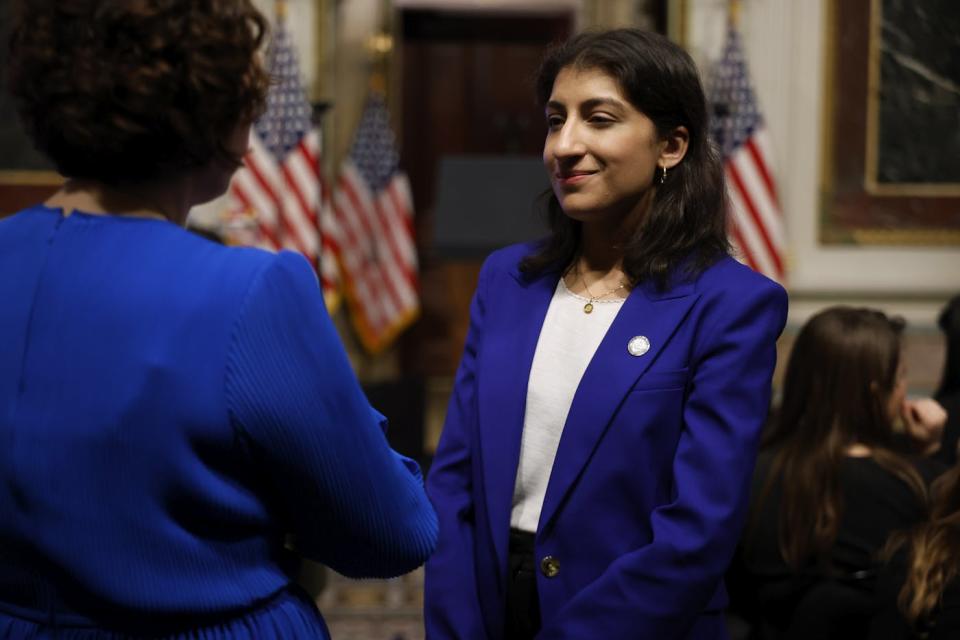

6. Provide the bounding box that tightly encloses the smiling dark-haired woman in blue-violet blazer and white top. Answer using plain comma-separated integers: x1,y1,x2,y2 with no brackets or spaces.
425,30,787,640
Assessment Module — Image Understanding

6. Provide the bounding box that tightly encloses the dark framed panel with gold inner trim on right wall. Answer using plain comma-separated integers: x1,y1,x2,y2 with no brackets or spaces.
820,0,960,246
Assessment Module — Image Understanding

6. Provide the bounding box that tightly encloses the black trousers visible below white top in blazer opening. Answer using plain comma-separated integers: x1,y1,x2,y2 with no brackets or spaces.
503,529,540,640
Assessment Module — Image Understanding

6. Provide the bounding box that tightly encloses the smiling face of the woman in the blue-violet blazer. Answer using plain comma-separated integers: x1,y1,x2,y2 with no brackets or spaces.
543,67,673,222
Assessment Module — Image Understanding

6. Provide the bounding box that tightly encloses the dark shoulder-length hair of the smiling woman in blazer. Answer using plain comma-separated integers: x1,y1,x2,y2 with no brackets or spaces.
521,29,730,289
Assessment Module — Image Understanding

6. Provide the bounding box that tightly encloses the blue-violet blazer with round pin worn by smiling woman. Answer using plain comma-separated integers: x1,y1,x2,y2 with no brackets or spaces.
425,245,787,640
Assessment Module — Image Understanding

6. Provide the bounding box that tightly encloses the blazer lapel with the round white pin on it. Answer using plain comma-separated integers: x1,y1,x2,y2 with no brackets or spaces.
537,285,697,535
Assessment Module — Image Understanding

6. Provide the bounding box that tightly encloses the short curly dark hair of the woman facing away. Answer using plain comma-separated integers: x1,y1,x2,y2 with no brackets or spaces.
8,0,268,184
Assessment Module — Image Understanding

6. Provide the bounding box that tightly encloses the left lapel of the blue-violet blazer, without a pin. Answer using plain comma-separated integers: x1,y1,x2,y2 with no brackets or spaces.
477,264,560,580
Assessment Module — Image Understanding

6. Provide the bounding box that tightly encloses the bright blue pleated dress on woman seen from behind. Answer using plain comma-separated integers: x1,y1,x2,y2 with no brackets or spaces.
0,206,437,640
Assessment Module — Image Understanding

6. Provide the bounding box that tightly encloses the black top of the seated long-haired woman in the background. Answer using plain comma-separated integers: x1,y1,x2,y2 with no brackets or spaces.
728,452,941,637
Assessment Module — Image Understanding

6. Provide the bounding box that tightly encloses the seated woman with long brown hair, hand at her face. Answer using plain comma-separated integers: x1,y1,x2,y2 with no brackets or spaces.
730,307,943,639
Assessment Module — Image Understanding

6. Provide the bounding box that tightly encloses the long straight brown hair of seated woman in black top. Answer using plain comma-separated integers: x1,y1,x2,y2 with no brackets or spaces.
755,306,925,570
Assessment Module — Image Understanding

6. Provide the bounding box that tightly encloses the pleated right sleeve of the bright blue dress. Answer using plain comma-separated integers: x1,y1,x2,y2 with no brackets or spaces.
225,252,437,577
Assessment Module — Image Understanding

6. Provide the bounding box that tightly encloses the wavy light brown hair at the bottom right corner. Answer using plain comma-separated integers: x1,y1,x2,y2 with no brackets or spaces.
886,465,960,626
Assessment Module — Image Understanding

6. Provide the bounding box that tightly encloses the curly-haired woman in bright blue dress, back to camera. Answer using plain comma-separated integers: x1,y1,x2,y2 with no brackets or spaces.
0,0,437,640
